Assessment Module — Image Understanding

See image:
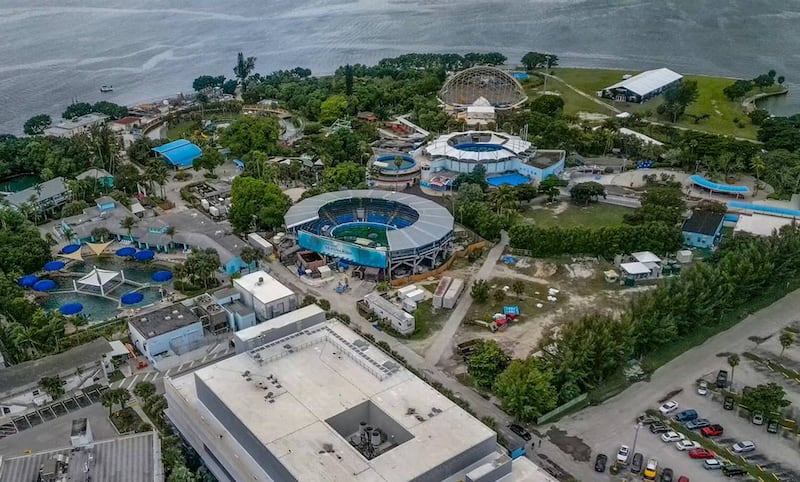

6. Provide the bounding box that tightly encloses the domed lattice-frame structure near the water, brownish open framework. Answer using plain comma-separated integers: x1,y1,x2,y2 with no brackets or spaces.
439,66,528,110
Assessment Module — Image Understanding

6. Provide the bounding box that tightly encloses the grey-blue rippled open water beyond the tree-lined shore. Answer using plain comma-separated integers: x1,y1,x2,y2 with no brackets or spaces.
0,0,800,133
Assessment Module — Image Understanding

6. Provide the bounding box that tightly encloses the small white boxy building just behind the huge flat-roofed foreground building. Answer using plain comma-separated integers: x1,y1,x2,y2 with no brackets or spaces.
233,271,297,321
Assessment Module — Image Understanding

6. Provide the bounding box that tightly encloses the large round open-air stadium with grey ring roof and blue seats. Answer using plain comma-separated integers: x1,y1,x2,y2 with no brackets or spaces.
284,190,453,278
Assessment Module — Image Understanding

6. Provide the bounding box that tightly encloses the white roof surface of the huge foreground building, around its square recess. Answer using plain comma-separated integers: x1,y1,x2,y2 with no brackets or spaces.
168,321,495,482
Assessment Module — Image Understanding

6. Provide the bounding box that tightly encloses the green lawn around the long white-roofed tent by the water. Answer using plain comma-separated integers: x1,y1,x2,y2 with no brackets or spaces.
548,68,758,139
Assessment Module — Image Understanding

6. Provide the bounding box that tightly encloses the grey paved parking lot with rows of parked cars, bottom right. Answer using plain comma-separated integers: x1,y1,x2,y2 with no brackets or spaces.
553,292,800,481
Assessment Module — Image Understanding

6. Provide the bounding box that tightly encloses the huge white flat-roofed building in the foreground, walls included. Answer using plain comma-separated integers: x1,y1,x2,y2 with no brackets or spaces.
164,321,540,482
